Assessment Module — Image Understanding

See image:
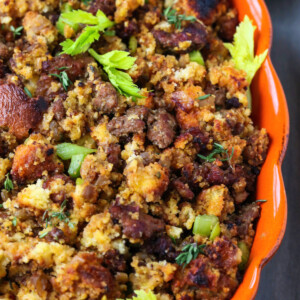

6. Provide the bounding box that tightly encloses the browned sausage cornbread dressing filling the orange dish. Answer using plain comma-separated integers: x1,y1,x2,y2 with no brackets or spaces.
0,0,269,300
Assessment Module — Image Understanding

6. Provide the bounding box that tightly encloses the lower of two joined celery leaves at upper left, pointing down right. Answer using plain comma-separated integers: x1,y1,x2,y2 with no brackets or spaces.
89,49,143,98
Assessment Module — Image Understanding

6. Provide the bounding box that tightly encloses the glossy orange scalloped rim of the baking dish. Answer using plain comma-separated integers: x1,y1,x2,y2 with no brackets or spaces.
232,0,289,300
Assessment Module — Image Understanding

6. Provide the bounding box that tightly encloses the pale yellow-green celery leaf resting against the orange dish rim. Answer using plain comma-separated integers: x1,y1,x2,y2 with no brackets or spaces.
224,15,268,84
